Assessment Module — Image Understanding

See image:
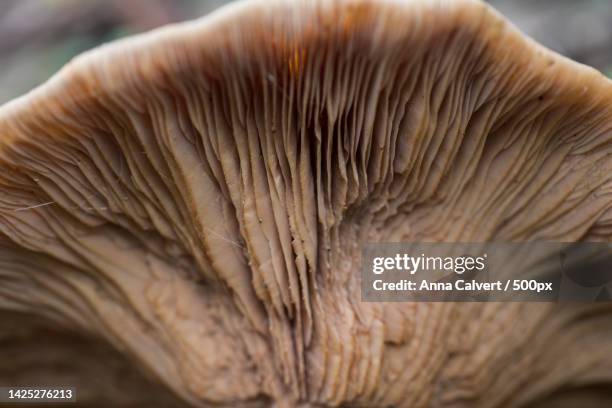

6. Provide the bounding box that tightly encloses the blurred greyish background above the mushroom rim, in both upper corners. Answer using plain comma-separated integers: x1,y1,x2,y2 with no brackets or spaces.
0,0,612,104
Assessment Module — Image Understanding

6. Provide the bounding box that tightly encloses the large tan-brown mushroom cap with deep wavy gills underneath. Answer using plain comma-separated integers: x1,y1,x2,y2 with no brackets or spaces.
0,0,612,407
